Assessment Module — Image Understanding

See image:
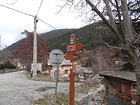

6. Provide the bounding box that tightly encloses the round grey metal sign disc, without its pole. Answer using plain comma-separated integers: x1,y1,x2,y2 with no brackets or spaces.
49,49,64,68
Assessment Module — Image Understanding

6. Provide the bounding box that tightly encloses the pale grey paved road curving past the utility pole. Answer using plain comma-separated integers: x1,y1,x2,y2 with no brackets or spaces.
0,71,69,105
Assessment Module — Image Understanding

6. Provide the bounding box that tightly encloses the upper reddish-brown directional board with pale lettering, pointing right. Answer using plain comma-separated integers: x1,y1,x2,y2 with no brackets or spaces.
67,43,83,52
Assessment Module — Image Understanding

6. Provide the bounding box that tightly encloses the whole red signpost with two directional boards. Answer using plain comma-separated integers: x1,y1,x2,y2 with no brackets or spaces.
64,34,83,105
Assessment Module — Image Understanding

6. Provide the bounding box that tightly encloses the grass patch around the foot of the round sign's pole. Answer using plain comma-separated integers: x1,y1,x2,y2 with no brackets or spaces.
34,93,79,105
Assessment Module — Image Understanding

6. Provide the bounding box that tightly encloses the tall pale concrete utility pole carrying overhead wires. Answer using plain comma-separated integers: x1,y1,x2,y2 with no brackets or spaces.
32,16,37,77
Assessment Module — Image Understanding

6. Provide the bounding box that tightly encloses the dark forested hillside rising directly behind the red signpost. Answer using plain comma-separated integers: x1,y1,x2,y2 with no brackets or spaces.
44,22,116,52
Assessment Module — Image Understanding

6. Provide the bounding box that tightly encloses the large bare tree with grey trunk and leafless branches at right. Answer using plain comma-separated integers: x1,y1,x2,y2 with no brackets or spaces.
60,0,140,104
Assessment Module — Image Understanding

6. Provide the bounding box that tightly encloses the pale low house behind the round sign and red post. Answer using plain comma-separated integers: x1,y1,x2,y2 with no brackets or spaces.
46,59,94,81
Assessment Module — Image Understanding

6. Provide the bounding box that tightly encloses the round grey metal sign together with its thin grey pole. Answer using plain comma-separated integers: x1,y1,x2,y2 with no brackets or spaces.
49,49,64,102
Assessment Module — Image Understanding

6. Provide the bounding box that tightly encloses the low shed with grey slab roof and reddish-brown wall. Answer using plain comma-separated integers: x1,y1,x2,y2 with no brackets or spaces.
99,71,138,104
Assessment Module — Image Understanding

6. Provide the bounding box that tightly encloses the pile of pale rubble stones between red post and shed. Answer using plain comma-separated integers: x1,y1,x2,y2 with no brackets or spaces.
75,74,106,105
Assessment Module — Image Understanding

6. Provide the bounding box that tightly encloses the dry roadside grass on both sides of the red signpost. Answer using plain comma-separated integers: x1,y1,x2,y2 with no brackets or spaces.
34,81,96,105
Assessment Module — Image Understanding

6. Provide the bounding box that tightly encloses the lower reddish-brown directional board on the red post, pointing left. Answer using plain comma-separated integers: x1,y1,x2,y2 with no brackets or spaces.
64,52,78,62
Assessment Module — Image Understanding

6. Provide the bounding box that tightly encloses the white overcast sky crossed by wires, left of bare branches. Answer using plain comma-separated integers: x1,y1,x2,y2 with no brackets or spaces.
0,0,85,48
